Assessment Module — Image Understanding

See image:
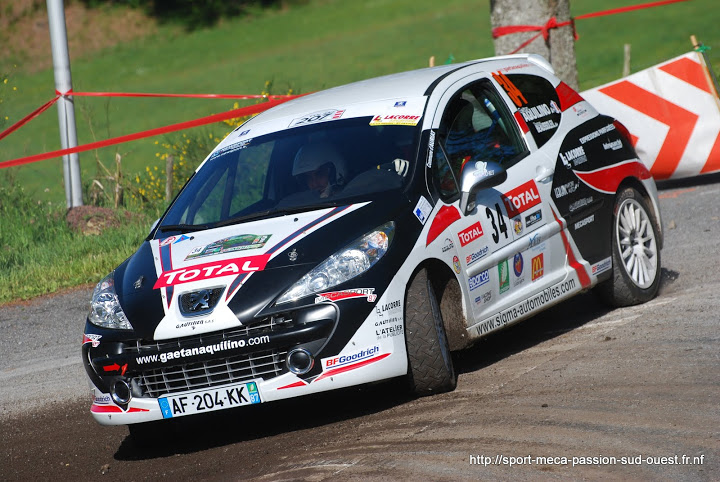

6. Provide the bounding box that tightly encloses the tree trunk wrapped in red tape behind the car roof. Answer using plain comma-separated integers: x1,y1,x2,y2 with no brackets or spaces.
490,0,578,90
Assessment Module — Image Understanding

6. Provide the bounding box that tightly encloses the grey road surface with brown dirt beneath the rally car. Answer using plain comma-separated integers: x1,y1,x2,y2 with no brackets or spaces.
0,177,720,481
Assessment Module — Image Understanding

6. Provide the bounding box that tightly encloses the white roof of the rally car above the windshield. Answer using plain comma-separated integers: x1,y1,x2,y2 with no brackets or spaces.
251,54,552,124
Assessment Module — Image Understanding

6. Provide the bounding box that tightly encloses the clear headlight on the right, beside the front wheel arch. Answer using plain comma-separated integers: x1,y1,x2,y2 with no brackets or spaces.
277,221,395,304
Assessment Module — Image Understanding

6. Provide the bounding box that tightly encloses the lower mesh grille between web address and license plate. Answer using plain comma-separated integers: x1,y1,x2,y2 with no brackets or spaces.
133,350,287,398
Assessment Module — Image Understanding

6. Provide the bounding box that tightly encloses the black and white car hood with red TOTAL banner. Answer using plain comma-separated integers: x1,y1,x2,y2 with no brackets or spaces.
115,199,407,340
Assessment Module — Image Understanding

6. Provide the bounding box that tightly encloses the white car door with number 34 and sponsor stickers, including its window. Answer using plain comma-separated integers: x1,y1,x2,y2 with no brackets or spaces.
431,76,567,335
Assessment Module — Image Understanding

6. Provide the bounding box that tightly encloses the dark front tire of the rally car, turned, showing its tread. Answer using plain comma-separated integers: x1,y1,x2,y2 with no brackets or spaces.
405,269,457,396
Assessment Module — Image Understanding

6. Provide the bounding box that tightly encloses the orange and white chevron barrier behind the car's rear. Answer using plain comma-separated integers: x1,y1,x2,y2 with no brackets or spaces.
581,51,720,180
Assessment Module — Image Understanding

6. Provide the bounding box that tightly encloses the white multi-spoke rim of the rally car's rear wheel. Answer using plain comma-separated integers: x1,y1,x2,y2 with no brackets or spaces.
616,199,658,289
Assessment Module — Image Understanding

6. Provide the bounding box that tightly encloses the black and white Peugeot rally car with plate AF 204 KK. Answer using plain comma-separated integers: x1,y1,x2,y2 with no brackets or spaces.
82,55,662,432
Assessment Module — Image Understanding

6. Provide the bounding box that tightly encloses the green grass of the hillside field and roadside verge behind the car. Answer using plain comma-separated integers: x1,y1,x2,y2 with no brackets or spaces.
0,0,720,302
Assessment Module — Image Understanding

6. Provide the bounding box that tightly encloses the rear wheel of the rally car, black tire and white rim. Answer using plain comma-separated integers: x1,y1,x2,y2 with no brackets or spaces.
596,187,660,307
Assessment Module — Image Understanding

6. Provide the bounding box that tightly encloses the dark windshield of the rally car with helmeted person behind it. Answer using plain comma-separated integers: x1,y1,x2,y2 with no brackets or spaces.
160,117,419,231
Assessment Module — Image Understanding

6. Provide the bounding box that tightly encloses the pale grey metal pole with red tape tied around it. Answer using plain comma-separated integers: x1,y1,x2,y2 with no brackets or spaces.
47,0,83,209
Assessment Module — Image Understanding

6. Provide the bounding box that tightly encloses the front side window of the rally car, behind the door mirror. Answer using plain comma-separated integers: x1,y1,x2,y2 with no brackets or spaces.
433,81,527,200
